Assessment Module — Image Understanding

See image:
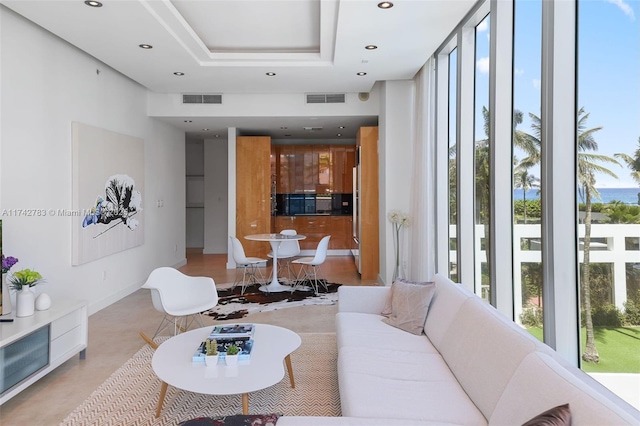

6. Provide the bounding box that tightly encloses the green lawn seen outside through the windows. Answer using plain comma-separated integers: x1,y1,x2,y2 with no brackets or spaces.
527,327,640,373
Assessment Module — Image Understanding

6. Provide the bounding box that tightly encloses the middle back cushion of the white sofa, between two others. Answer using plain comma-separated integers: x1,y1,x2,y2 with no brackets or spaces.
440,297,536,423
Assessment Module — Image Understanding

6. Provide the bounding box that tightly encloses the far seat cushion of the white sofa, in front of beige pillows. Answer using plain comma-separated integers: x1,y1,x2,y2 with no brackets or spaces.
336,312,438,353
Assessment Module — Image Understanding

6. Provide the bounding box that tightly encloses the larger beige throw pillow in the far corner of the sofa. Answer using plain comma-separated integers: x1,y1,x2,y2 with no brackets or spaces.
382,280,436,334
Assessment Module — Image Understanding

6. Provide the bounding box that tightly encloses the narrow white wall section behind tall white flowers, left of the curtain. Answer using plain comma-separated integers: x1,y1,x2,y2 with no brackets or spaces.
378,80,417,285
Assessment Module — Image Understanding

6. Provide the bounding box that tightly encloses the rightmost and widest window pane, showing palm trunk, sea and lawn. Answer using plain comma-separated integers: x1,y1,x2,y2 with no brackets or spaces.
576,0,640,380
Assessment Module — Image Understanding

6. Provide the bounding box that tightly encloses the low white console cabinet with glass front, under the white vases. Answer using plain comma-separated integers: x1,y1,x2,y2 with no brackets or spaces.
0,300,88,405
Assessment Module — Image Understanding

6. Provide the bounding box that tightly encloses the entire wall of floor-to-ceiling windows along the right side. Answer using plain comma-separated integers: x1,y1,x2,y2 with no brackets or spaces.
436,0,640,406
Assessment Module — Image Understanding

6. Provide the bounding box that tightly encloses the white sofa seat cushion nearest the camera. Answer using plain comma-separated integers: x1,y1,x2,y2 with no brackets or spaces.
338,348,486,426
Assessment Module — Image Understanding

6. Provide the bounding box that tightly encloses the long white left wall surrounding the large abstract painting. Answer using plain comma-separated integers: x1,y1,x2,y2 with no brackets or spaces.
0,7,185,313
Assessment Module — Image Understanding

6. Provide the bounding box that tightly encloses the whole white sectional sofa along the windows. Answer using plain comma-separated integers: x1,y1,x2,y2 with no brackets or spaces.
278,275,640,426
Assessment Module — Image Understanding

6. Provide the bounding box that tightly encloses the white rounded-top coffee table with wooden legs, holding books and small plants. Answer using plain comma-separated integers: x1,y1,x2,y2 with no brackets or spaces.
151,324,301,417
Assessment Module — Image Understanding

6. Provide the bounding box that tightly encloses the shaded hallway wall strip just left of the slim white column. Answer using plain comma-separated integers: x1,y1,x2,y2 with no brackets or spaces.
204,139,229,254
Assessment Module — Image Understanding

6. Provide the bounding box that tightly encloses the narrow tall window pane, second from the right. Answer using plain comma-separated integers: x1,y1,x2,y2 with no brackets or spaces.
512,0,544,339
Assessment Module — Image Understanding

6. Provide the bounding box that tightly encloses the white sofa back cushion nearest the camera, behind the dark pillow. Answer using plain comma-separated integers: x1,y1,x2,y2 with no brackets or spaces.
489,352,637,426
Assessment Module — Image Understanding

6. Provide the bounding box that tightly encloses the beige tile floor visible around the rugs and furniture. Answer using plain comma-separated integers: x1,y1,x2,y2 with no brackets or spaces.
0,250,375,426
